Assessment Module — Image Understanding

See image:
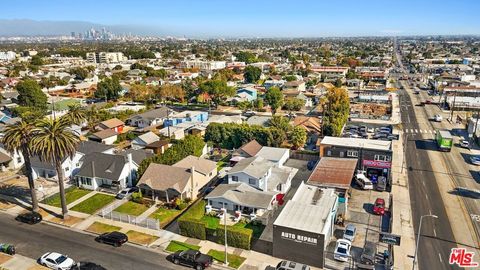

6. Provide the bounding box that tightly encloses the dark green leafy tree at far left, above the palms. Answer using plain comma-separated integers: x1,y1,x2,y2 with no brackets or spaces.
16,79,48,112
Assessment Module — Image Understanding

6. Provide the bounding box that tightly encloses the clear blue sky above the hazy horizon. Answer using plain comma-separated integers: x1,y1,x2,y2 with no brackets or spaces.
0,0,480,37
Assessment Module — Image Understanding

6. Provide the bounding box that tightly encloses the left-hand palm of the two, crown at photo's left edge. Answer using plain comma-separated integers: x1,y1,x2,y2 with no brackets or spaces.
2,121,38,212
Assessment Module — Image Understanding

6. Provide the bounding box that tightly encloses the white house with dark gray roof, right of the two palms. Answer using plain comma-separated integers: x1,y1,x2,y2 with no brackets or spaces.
75,153,138,192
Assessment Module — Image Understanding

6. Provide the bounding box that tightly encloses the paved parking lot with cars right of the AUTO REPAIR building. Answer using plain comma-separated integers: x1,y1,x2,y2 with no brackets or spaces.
326,182,389,269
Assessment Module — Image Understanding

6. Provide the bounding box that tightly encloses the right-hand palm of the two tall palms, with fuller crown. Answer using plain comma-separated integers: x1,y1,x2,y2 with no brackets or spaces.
31,117,79,218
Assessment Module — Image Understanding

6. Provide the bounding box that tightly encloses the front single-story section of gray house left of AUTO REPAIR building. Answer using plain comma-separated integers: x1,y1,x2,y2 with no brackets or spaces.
205,183,276,218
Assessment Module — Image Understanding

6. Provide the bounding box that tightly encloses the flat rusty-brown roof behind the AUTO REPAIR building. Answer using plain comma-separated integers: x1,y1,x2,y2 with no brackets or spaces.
307,157,357,189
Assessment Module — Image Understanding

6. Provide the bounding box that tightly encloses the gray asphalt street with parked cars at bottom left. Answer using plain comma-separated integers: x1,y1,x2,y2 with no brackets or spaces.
0,213,182,270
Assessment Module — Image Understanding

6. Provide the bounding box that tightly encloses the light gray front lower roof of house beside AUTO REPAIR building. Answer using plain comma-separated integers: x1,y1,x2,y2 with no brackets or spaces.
205,183,275,209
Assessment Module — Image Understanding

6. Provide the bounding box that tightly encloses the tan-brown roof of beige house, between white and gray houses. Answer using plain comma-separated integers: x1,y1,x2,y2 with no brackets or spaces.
137,163,192,193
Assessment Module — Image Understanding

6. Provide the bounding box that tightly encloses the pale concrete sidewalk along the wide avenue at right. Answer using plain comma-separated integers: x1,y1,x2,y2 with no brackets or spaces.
391,131,415,269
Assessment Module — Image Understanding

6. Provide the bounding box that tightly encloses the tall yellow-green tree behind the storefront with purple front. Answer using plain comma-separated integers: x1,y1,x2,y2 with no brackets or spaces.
323,88,350,136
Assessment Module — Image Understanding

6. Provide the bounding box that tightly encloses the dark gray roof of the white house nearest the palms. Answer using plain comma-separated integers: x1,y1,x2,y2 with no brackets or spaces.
76,153,127,180
